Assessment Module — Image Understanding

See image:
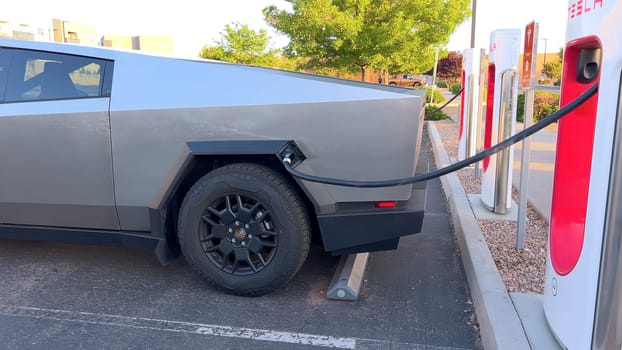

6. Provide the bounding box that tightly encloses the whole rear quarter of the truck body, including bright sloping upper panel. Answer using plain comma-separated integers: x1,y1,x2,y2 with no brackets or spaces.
111,58,423,226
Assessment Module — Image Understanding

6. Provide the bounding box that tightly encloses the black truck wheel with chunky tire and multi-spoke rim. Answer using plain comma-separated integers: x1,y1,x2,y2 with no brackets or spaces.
178,163,311,296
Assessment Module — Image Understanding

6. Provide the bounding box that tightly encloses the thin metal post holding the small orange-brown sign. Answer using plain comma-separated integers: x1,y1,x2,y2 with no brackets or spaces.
516,23,539,250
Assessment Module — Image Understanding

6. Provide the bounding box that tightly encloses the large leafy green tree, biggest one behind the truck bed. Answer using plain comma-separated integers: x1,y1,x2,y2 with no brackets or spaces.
264,0,470,80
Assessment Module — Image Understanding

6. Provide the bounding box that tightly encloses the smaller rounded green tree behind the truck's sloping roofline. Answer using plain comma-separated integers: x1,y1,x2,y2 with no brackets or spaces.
199,23,282,67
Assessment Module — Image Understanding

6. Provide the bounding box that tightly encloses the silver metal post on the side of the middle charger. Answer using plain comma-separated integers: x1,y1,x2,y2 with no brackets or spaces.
494,69,516,214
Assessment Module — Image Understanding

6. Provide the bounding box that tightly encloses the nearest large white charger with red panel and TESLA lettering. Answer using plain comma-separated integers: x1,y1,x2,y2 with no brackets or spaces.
543,0,622,349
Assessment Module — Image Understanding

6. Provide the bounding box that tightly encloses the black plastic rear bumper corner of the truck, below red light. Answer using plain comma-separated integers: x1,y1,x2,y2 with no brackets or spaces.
318,186,426,255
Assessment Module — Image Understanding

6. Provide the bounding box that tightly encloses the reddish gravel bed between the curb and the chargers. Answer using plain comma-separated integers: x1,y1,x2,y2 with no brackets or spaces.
434,120,548,294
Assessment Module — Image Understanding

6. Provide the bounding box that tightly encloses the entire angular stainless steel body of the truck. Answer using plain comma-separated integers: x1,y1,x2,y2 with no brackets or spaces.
0,40,424,260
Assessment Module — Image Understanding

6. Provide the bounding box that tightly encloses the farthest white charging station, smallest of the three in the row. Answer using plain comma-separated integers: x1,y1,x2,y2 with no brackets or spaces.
458,49,479,160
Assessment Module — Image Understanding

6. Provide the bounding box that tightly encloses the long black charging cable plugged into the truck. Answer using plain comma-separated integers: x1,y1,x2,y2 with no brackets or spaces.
283,83,598,188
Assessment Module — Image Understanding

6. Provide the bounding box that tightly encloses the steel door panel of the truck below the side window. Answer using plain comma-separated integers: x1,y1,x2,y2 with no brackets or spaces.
0,98,119,229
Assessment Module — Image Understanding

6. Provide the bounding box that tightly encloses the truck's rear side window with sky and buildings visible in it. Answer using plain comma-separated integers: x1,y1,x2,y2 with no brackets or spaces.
5,50,109,102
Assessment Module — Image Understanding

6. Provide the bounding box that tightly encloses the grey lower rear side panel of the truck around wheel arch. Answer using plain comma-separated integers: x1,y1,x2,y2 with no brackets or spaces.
111,101,424,230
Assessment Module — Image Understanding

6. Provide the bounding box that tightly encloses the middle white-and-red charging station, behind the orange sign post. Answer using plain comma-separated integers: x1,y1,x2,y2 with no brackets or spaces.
481,29,520,214
